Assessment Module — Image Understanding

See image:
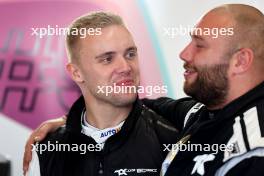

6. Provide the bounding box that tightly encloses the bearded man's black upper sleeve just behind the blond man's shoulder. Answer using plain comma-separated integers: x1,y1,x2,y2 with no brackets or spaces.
142,97,197,131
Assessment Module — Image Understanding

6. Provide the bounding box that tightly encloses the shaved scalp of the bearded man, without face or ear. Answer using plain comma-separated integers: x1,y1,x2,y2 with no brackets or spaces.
205,4,264,69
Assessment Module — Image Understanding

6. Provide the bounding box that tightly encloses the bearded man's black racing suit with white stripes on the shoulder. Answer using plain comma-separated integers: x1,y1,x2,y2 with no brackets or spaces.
144,82,264,176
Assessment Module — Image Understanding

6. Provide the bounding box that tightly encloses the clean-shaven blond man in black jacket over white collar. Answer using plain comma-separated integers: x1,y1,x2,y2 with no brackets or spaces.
25,12,177,176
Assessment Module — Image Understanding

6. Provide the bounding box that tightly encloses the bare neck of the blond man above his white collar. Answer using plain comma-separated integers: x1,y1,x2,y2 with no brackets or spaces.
84,97,132,129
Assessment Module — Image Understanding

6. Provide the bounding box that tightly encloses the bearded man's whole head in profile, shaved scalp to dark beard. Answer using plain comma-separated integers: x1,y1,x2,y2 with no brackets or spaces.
183,4,264,109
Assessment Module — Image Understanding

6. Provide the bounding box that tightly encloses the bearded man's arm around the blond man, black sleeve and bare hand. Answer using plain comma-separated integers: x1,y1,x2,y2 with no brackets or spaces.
23,97,196,173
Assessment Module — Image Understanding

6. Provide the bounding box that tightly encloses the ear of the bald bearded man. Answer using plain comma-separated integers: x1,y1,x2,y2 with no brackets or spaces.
231,48,254,75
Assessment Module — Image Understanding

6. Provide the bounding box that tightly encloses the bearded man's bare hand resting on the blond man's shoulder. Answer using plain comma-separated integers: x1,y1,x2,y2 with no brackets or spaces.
23,116,67,175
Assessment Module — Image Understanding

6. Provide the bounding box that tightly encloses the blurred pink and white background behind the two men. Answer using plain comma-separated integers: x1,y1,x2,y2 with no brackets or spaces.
0,0,264,176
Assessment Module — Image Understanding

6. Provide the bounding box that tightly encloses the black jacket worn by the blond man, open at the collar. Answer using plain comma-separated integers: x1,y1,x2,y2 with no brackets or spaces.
38,97,178,176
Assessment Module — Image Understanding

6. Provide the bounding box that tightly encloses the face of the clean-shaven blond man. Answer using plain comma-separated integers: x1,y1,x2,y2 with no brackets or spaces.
75,25,140,106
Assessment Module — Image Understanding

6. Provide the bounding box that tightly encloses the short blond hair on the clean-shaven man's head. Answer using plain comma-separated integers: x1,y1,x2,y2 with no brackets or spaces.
66,11,125,62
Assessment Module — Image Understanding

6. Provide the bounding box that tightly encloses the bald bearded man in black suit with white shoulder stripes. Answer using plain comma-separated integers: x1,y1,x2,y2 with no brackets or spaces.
23,4,264,176
